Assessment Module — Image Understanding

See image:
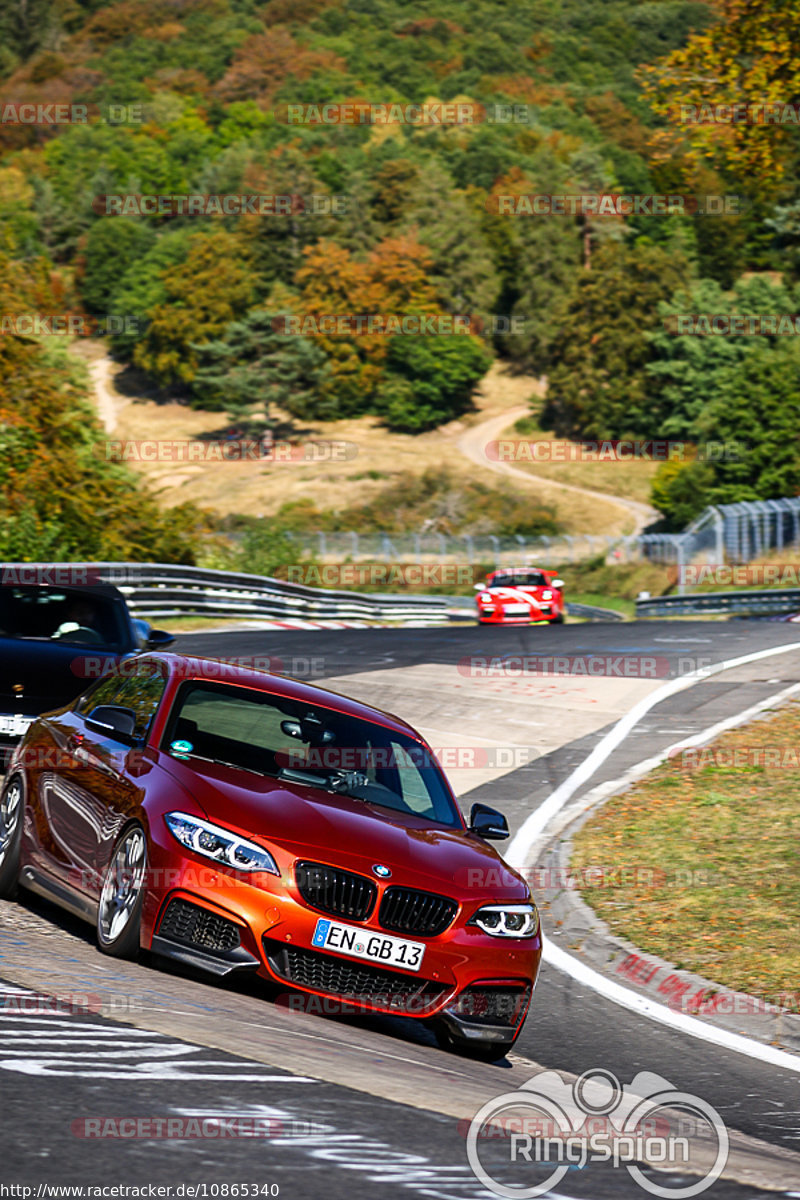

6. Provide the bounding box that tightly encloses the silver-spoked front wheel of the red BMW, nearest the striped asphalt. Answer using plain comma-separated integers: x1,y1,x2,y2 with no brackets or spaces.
97,824,148,959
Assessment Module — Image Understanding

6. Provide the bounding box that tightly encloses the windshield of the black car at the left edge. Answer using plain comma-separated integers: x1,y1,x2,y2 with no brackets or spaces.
0,586,125,649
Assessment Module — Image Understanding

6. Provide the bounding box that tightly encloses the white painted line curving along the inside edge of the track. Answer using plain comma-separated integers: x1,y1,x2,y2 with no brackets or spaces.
506,642,800,1072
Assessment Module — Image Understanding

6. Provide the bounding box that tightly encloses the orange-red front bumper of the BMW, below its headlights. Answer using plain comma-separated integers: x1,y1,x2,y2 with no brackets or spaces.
142,846,541,1040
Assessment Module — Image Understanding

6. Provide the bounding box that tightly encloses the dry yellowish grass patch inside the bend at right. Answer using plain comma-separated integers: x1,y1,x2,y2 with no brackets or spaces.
572,703,800,1008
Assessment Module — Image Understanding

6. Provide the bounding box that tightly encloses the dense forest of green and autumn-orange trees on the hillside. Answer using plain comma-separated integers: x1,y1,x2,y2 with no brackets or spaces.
0,0,800,558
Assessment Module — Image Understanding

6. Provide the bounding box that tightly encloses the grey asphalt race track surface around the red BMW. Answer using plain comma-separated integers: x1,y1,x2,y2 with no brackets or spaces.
0,622,800,1200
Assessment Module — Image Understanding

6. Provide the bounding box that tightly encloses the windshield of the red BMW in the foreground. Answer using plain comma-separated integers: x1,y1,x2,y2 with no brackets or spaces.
161,680,461,827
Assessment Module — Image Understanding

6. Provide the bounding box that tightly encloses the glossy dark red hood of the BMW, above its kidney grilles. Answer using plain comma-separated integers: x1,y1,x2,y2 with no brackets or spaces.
160,752,528,900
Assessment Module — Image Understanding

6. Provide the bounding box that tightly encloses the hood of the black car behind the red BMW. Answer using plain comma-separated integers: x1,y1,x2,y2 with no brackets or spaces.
0,637,120,715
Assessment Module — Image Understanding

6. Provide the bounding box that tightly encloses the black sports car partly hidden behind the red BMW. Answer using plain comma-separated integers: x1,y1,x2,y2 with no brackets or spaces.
0,583,174,770
